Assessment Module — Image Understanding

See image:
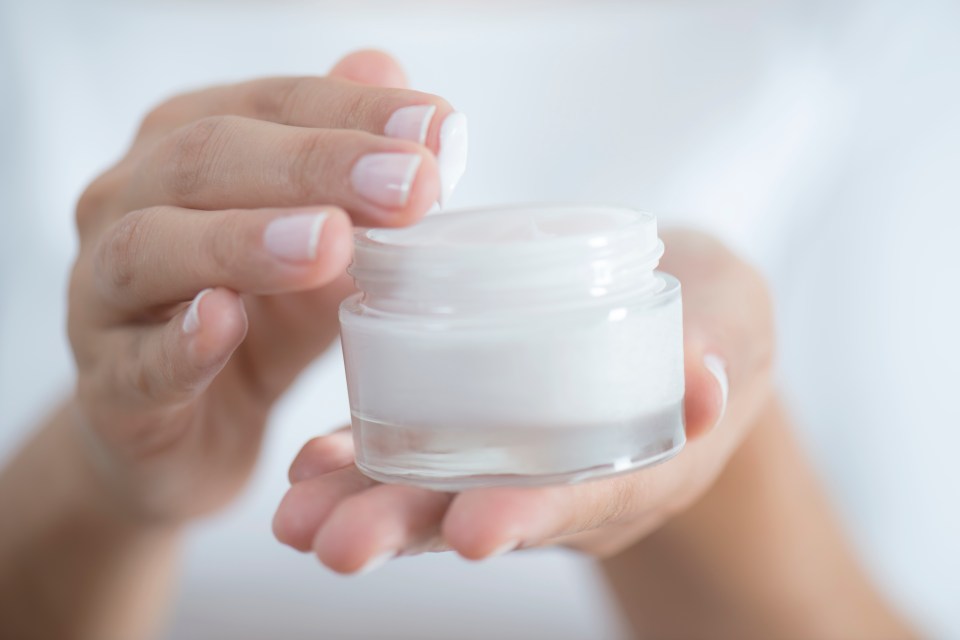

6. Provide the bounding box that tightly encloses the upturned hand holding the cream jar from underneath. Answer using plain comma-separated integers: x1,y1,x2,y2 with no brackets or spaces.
274,231,774,573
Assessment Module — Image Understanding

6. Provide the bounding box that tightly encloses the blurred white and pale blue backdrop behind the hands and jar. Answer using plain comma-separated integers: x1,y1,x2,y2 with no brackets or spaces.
0,0,960,640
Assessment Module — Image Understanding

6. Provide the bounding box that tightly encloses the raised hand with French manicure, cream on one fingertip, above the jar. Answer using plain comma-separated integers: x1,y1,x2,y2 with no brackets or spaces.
69,52,466,522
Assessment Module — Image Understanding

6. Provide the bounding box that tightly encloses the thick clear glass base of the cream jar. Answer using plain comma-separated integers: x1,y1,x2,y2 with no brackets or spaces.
353,403,686,491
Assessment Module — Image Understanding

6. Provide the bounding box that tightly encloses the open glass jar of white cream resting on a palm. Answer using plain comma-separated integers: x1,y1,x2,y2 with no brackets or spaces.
340,205,684,491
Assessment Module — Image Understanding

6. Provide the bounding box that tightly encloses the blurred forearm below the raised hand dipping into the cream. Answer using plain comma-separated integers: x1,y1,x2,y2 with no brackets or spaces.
0,409,179,640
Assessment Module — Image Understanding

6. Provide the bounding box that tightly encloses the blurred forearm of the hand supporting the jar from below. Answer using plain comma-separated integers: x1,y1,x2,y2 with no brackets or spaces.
603,401,913,640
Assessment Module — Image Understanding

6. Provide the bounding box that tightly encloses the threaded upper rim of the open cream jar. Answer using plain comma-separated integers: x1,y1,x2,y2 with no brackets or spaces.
347,204,664,313
